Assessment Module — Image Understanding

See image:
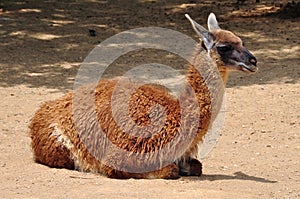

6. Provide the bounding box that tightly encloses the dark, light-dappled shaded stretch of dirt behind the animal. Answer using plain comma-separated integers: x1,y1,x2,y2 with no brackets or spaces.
0,0,300,91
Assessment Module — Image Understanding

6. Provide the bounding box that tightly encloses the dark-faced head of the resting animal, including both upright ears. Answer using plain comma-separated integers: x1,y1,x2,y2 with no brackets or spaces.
185,13,258,73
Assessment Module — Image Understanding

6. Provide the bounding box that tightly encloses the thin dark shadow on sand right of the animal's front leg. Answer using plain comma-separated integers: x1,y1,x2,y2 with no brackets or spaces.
189,171,277,183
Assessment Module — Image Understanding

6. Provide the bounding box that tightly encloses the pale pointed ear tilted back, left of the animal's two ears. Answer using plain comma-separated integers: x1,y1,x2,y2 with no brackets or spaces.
185,14,214,51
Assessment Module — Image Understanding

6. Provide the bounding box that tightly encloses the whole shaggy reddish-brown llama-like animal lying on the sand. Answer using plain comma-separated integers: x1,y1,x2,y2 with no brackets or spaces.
29,14,257,179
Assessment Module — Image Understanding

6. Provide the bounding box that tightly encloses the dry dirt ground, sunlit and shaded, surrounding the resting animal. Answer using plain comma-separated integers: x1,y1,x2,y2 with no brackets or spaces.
0,0,300,198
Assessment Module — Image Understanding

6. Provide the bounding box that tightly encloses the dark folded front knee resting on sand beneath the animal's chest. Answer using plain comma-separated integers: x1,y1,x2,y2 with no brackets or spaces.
178,157,202,176
